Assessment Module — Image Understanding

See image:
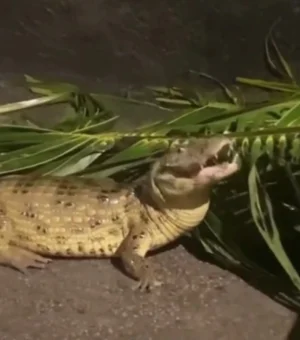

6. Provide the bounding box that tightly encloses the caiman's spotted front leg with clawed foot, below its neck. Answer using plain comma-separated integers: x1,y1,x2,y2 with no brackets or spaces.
117,228,162,292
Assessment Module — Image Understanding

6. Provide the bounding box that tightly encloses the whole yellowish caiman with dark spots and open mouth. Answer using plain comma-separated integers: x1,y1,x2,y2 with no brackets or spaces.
0,136,239,291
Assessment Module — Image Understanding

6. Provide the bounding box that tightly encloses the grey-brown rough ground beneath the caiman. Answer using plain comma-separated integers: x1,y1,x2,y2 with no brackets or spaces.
0,240,296,340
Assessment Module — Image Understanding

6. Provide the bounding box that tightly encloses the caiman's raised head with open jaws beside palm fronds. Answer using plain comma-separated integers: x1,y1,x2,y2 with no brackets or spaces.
149,136,239,208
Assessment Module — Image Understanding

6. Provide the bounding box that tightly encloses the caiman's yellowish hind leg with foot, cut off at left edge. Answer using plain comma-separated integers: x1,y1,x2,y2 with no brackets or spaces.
0,207,51,273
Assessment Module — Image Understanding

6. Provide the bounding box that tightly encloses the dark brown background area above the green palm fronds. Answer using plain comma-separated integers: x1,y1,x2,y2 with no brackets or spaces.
0,0,300,89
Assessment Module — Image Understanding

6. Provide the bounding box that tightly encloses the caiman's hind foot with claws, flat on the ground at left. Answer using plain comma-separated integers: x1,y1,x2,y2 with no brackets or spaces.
0,246,51,274
